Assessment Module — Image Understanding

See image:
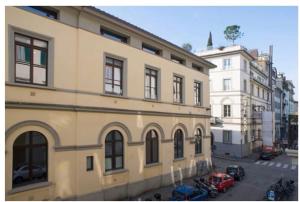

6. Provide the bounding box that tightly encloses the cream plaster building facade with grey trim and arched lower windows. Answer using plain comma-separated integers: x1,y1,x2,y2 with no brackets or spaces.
5,7,215,200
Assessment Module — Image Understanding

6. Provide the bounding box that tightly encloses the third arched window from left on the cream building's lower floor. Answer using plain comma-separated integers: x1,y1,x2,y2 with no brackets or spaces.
146,130,158,164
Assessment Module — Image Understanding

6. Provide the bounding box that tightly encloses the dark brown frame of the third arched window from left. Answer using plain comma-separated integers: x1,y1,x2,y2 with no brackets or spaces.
145,129,159,165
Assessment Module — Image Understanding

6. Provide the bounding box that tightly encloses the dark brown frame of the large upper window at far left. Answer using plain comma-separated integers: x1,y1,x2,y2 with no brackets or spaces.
14,32,49,86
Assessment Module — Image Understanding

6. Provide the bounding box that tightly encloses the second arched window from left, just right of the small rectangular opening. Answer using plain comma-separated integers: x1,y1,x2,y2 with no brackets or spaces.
105,130,124,171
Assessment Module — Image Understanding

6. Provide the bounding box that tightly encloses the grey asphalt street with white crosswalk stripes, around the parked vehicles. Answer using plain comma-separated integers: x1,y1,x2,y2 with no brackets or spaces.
133,154,298,201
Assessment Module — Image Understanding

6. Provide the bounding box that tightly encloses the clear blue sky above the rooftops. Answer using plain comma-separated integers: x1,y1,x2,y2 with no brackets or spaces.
98,6,298,100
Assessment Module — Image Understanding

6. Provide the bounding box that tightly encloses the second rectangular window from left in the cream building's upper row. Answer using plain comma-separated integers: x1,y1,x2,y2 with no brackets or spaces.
105,57,123,95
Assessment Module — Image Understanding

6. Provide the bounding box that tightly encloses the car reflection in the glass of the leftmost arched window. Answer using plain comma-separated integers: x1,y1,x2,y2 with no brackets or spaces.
13,164,46,184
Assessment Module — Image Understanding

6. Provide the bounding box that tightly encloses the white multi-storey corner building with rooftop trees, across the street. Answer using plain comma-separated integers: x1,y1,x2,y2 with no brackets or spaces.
197,46,274,157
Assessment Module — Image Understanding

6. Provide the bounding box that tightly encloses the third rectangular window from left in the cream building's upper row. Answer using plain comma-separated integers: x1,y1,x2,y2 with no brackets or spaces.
145,68,158,100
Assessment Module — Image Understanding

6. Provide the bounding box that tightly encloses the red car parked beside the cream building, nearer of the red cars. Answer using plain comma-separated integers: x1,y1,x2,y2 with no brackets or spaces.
209,173,234,192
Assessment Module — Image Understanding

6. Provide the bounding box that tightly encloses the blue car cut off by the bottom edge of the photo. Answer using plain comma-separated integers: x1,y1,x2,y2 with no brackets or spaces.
170,185,208,201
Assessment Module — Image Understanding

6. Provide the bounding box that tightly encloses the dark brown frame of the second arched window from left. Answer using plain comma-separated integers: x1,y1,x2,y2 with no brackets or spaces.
104,130,125,172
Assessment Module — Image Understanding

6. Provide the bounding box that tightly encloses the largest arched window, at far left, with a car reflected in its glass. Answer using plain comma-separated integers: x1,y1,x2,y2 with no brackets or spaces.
12,131,48,187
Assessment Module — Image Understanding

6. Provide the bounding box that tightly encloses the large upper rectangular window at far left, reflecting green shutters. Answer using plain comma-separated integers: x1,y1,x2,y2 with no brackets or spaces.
15,33,48,86
